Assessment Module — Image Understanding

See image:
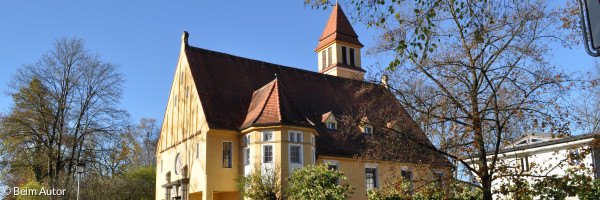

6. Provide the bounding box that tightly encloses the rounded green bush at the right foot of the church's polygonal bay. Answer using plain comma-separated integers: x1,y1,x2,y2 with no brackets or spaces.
289,164,354,200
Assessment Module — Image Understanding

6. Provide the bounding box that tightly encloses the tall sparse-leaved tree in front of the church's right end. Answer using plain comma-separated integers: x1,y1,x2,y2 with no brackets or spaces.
306,0,572,199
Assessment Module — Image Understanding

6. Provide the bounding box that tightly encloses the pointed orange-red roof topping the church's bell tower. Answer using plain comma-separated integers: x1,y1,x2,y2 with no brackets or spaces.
315,4,363,51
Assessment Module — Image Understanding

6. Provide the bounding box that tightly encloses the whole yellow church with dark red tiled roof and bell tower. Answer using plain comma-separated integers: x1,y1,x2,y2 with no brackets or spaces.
156,5,452,200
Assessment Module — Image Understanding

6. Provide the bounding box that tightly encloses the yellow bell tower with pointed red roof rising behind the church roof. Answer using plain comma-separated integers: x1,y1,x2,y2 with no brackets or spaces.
315,3,366,80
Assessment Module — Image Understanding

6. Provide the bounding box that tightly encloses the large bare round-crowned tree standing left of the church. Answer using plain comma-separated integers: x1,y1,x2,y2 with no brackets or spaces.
0,38,127,189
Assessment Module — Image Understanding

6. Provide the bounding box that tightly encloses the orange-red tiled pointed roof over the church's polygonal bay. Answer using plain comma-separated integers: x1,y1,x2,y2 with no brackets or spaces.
241,78,314,129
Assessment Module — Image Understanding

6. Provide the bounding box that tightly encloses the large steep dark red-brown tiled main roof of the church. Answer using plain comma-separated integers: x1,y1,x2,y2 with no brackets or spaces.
185,45,449,165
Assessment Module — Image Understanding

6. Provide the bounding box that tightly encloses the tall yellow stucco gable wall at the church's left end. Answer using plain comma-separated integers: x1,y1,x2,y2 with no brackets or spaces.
156,41,208,199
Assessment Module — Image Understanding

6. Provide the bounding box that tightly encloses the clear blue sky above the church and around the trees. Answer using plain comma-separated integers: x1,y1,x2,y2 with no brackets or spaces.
0,0,594,122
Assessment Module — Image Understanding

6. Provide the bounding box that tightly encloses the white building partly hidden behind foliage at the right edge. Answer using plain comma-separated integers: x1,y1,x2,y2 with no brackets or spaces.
469,133,600,199
